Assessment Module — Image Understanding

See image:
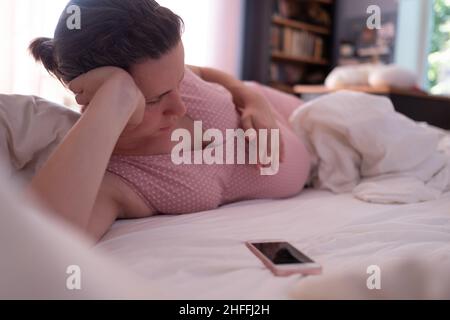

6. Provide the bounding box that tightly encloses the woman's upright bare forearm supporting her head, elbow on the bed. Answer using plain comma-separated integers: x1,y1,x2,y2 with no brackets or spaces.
30,69,144,230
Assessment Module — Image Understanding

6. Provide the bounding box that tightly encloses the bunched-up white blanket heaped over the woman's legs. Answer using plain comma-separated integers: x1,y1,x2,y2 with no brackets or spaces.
291,91,450,203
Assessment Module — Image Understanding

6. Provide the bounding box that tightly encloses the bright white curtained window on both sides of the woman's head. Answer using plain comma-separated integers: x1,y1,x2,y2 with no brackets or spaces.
0,0,243,105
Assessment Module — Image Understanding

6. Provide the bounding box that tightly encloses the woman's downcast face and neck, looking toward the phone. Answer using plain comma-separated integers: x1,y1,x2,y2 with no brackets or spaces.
118,41,186,147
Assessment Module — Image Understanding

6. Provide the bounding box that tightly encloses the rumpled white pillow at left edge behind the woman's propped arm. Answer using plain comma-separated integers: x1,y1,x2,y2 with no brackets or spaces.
0,94,80,186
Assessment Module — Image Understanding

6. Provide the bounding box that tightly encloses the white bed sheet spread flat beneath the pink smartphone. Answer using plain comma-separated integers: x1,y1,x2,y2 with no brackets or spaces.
98,190,450,299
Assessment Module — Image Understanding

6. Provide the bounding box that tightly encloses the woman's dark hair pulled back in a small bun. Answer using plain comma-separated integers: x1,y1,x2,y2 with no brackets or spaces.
29,0,183,83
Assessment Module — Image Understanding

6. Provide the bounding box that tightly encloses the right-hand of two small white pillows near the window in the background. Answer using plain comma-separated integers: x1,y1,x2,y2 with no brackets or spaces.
369,65,417,89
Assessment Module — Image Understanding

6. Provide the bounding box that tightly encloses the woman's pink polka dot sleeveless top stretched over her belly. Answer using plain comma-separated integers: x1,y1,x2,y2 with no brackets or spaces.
107,68,310,214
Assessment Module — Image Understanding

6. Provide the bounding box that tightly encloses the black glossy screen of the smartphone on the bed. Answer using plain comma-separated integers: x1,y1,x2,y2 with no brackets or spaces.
252,242,314,264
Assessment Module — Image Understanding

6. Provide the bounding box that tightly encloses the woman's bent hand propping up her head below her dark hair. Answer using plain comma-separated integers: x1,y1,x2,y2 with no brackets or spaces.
69,67,145,127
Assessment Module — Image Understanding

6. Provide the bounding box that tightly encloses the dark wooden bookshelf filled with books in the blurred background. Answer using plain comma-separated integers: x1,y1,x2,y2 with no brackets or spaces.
243,0,335,93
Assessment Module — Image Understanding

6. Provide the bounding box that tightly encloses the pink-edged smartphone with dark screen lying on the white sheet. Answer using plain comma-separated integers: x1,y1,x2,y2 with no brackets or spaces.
245,240,322,277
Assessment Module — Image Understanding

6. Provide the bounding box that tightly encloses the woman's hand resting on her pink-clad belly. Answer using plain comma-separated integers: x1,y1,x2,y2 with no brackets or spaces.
233,86,284,162
